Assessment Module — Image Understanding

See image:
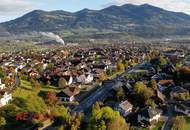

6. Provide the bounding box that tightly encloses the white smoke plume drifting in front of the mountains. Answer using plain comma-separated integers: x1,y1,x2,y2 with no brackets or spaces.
40,32,65,45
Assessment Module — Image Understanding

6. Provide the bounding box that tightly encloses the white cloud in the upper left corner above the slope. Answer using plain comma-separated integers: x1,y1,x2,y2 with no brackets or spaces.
0,0,35,16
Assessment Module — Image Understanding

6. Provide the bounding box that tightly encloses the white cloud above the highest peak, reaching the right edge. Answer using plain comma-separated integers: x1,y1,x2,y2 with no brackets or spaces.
107,0,190,14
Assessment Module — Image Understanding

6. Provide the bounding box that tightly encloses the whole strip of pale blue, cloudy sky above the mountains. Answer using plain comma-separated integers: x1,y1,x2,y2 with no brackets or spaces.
0,0,190,22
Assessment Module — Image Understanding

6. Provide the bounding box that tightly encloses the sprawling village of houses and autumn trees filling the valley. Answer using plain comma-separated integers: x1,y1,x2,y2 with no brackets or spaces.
0,44,190,130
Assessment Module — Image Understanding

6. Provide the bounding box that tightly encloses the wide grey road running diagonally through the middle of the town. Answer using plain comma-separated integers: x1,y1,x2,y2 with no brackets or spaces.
72,64,141,113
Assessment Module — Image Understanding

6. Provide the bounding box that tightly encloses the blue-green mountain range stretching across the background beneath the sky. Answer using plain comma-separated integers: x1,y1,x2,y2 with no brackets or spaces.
0,4,190,37
